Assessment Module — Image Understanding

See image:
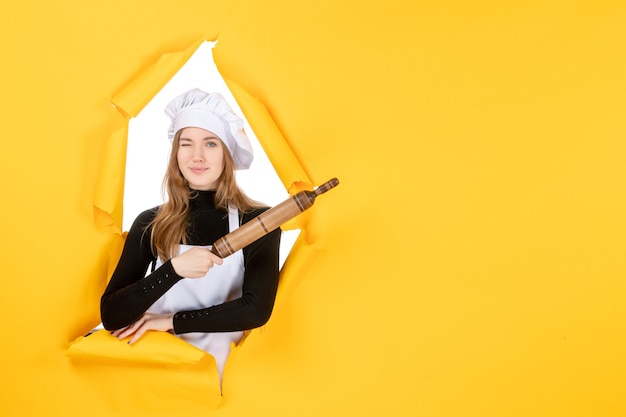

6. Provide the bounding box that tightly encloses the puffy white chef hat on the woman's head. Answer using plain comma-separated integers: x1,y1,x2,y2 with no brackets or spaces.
165,88,253,169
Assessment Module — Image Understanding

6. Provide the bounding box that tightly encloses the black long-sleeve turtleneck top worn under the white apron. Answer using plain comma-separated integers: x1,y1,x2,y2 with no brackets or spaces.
100,191,280,334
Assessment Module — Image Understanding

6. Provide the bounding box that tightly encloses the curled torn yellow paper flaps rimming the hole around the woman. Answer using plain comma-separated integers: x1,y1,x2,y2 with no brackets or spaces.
83,40,313,366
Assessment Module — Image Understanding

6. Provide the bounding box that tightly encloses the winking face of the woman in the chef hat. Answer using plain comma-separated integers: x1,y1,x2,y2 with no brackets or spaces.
177,127,224,190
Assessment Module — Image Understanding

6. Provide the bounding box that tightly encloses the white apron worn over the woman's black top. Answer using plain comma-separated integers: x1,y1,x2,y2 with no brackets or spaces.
148,207,244,379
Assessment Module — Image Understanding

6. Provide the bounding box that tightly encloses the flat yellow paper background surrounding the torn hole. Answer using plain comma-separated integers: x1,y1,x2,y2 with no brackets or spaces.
0,0,626,416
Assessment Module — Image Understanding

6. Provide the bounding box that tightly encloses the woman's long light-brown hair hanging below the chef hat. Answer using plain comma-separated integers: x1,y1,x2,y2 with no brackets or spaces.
148,129,264,262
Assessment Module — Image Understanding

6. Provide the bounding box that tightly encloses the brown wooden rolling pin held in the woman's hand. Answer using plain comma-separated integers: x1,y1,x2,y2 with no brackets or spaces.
211,178,339,258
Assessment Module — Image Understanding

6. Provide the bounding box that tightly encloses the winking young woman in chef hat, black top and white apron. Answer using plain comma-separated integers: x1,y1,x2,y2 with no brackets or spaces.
100,89,280,375
